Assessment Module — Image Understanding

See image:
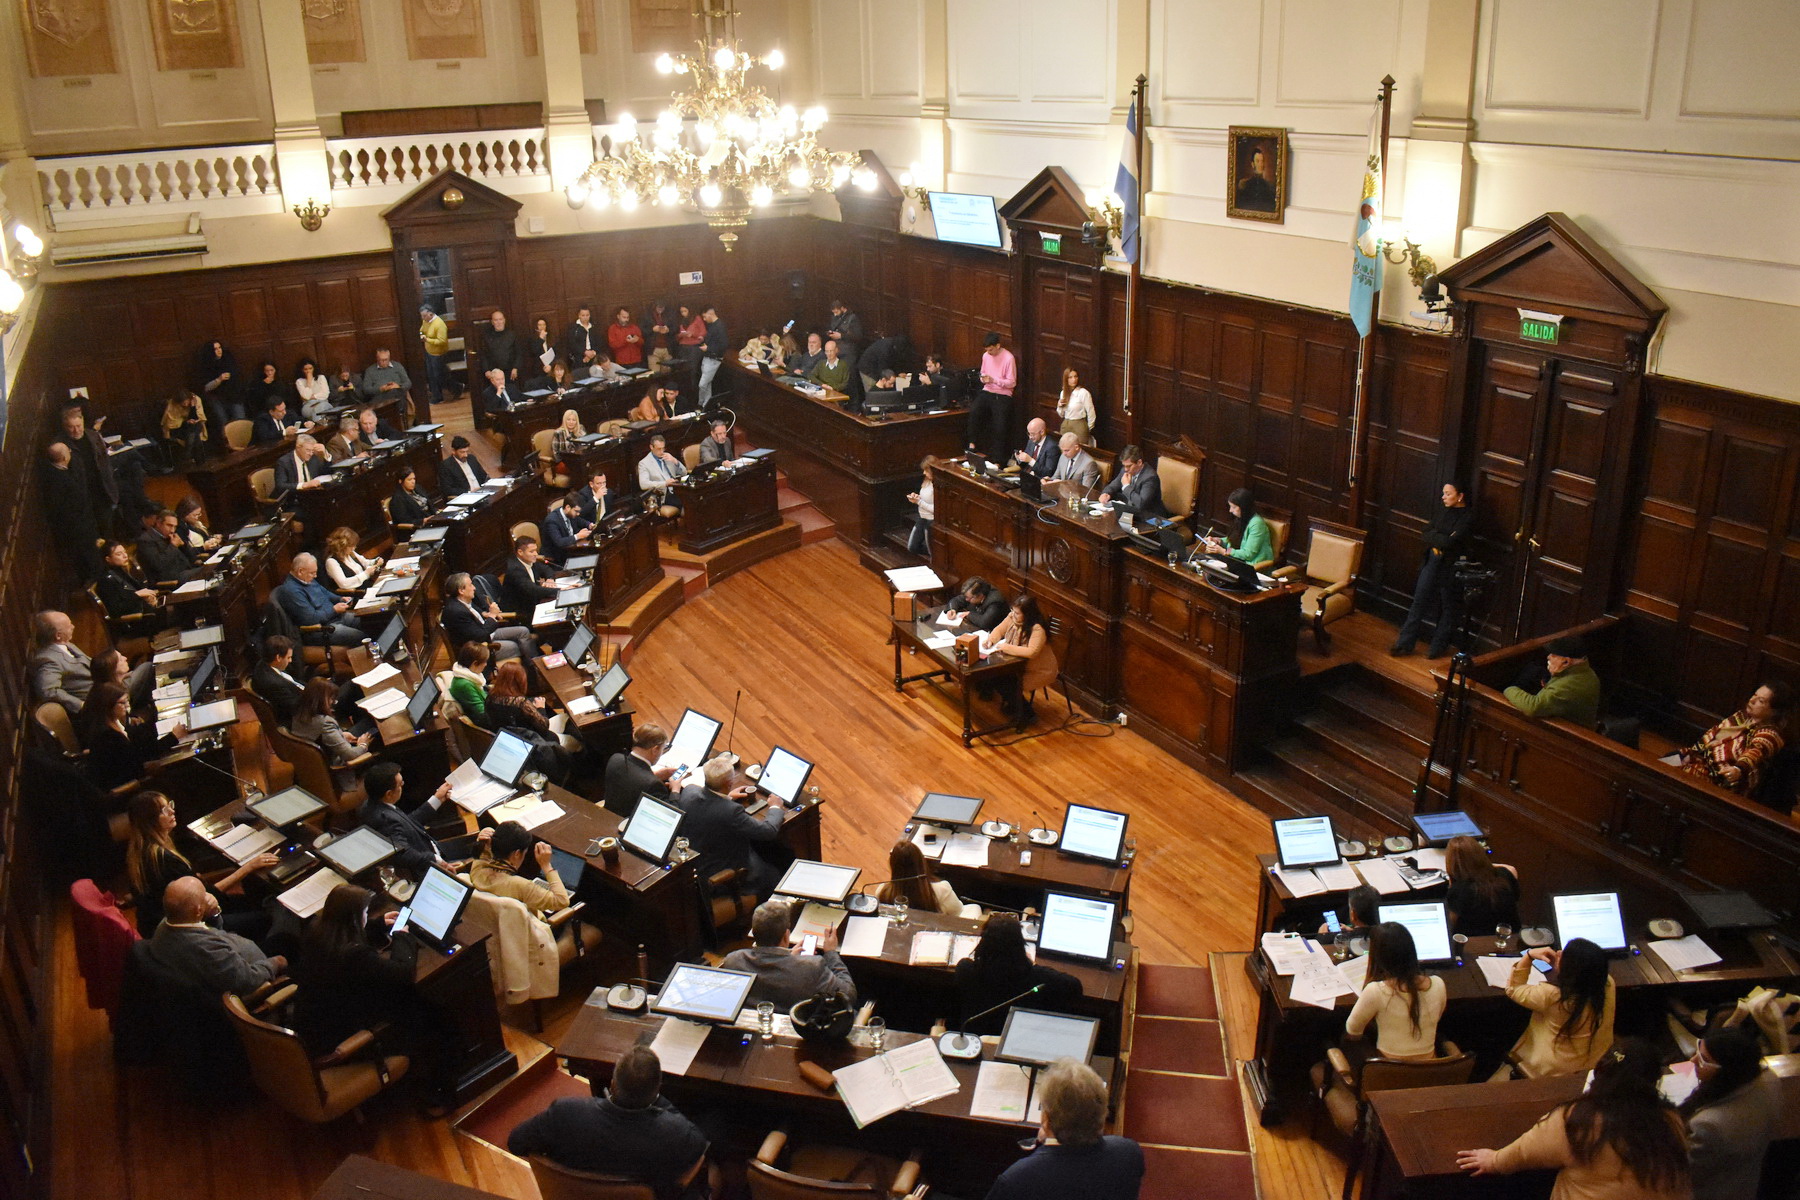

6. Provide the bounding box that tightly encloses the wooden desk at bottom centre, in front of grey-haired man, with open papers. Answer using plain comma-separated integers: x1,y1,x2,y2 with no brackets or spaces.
556,1002,1118,1196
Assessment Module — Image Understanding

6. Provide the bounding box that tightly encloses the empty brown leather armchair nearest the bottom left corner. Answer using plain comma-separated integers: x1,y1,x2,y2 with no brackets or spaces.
225,997,412,1124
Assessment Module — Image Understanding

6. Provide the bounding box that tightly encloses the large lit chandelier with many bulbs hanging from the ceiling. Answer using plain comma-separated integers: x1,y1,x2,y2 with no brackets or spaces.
565,9,875,250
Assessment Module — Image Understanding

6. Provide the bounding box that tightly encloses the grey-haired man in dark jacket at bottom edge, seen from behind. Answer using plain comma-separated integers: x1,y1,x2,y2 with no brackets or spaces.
988,1058,1143,1200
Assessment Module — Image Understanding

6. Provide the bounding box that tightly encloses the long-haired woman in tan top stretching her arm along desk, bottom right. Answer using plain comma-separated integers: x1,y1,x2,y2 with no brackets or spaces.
1456,1038,1692,1200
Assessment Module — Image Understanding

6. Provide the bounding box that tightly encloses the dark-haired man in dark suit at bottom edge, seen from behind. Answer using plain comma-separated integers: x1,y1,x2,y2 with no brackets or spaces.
506,1045,706,1196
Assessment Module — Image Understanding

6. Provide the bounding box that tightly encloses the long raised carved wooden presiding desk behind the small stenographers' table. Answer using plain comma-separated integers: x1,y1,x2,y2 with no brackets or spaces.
932,459,1301,775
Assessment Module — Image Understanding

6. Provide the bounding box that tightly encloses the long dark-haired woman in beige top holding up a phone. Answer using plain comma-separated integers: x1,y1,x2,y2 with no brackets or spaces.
1496,937,1613,1079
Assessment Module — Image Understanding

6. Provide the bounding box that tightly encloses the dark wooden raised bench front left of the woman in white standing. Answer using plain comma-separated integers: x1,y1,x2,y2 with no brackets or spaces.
720,356,968,549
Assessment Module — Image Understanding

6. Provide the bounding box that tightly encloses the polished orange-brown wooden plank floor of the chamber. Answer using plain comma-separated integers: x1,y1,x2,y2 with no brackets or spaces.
49,406,1336,1200
